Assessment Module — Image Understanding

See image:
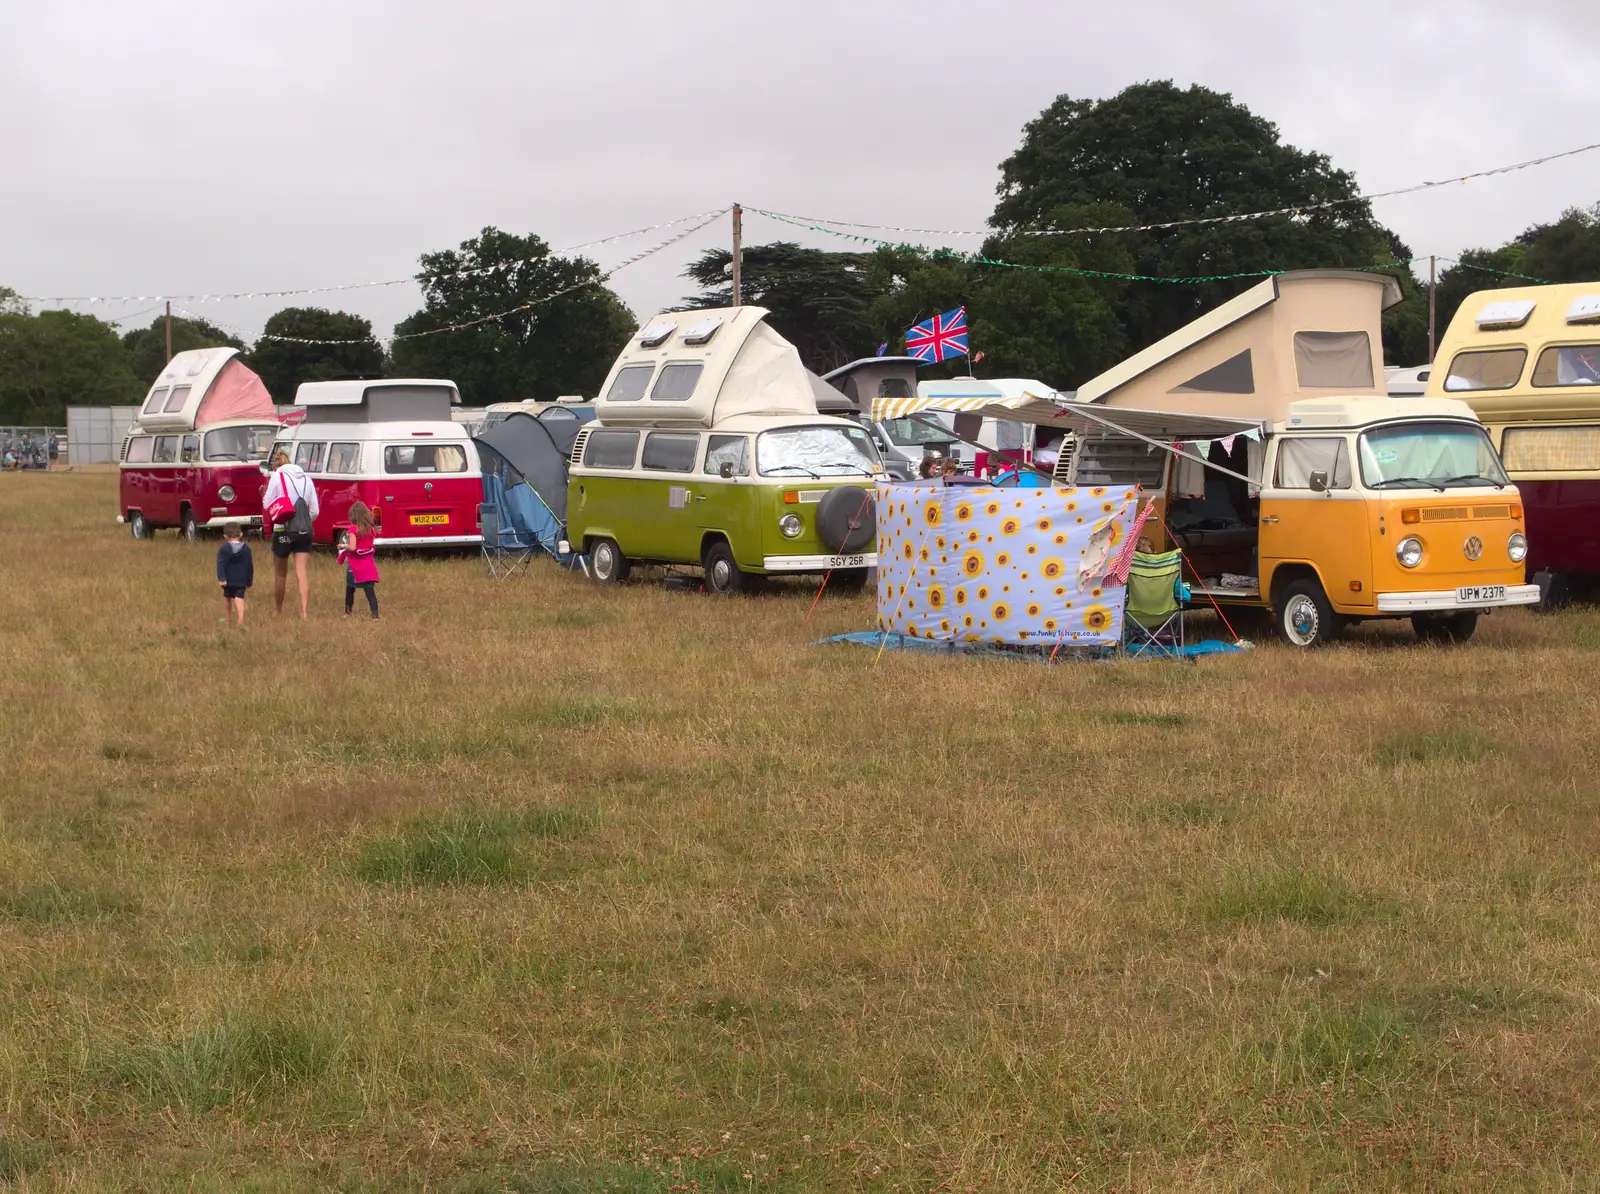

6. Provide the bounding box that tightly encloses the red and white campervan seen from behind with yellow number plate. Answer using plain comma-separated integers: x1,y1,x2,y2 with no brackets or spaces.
258,379,483,547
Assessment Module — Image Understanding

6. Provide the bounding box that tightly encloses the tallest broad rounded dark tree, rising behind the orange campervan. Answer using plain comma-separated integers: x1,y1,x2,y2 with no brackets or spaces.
989,82,1387,349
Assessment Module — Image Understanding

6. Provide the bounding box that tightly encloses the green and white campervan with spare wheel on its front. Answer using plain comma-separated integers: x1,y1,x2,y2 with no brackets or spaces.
566,307,885,594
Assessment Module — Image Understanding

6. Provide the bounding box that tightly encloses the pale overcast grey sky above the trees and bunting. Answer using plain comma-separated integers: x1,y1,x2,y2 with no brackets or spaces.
0,0,1600,348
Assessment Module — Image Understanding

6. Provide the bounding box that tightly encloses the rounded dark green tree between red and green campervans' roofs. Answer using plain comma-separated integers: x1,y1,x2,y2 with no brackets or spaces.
394,227,637,407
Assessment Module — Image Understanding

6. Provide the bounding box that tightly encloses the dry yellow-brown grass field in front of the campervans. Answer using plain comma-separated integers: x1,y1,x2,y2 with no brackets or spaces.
0,474,1600,1194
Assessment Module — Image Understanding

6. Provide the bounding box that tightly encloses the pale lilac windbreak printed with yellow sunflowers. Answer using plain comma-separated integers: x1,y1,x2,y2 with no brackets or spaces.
877,482,1136,647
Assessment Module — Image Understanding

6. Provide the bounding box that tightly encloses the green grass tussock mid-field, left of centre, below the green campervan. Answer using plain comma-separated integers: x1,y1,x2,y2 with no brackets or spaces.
355,808,592,887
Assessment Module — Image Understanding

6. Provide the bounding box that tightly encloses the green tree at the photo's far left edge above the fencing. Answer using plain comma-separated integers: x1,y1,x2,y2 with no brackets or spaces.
0,311,147,426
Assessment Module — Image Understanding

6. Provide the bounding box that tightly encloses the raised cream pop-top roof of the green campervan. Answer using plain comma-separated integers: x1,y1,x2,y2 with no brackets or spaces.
595,307,816,427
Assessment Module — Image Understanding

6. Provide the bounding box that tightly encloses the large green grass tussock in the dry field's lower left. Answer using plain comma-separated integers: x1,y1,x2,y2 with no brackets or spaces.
112,1015,339,1111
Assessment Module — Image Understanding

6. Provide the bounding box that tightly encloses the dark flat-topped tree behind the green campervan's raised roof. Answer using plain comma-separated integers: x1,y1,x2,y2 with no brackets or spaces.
683,240,882,373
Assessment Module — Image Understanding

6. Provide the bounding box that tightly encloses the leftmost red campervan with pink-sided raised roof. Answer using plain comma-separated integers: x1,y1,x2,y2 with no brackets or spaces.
117,347,280,539
